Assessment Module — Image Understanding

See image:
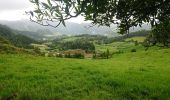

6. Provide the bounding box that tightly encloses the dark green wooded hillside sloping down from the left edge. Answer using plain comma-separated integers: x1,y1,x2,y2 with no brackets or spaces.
0,24,36,48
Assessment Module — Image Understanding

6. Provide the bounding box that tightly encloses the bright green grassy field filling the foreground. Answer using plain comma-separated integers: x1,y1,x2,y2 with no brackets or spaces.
0,49,170,100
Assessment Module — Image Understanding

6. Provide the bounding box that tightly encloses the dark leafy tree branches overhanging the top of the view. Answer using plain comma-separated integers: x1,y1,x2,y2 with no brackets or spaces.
30,0,170,34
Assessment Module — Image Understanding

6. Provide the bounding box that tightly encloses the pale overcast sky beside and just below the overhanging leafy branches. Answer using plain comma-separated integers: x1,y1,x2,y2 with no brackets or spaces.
0,0,84,23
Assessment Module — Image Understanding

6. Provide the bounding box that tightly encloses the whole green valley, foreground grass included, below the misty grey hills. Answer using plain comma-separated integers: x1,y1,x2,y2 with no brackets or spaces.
0,22,170,100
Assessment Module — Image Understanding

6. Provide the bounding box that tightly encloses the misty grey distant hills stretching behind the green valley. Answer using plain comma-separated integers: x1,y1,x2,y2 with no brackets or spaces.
0,20,150,39
